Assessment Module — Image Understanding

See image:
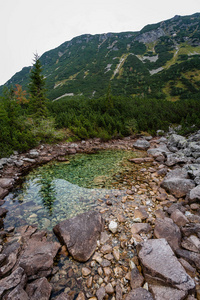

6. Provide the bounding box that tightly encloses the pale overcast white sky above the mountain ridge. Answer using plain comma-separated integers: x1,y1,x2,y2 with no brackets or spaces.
0,0,200,85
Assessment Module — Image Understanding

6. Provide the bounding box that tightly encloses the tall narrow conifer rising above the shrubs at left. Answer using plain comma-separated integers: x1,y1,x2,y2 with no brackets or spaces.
29,53,48,118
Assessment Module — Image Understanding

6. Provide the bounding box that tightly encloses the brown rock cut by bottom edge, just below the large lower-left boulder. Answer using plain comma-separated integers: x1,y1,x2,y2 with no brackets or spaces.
26,277,52,300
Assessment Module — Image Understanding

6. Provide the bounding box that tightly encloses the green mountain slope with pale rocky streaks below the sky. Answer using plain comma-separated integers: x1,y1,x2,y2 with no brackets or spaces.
0,13,200,101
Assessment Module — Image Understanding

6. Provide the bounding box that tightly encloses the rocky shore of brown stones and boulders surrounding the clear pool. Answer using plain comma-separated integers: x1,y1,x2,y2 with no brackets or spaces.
0,131,200,300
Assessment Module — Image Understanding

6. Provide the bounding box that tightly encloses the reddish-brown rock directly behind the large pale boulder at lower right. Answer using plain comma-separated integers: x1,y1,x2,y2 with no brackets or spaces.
154,218,181,250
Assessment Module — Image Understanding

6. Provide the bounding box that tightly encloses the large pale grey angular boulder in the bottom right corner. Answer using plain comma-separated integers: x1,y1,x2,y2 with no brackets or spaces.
138,239,195,292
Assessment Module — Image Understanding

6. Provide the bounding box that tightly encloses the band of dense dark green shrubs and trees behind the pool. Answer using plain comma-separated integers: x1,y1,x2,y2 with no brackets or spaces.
0,64,200,157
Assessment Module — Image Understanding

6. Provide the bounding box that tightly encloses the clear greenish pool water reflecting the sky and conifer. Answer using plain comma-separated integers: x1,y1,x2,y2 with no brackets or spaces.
4,150,142,230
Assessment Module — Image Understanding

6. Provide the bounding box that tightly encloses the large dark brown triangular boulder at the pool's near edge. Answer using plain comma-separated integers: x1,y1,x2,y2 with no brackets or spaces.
53,211,104,262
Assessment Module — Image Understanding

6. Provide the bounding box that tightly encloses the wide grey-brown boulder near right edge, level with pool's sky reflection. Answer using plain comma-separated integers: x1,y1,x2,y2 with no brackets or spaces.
161,177,195,198
